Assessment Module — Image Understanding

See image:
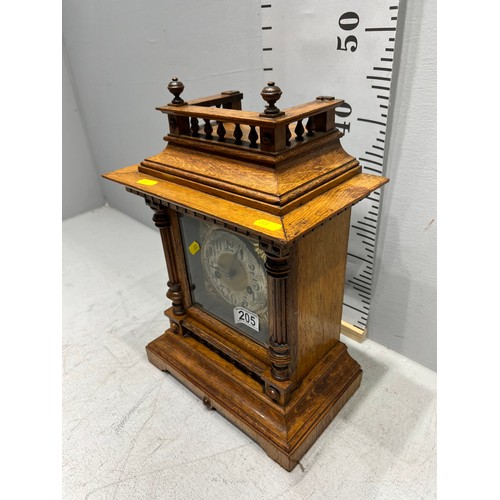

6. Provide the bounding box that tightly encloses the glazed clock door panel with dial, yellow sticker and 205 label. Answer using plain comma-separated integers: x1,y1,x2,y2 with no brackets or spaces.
180,216,269,345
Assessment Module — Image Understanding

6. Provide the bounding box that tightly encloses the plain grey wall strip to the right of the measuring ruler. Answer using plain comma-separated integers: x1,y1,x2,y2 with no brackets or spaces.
368,0,437,370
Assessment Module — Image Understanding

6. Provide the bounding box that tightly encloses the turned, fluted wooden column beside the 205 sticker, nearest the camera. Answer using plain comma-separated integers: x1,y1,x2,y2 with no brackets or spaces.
261,242,291,380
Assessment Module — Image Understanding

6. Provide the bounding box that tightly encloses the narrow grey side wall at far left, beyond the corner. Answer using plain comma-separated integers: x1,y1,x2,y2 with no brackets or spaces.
62,40,104,219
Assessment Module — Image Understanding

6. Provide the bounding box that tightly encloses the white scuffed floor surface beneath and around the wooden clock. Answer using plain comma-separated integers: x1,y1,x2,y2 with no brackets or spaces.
63,207,436,500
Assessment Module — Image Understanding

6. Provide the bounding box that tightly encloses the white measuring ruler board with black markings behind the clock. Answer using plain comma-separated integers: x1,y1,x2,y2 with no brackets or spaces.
261,0,399,339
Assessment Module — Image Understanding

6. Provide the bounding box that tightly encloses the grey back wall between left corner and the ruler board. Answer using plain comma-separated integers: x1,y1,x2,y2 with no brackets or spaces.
63,0,265,224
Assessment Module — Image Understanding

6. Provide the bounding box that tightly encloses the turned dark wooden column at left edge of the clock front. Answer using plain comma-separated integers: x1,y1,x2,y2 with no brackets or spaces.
148,203,186,316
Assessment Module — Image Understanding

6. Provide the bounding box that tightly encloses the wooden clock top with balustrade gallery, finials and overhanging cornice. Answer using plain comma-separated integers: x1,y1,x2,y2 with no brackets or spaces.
104,78,388,243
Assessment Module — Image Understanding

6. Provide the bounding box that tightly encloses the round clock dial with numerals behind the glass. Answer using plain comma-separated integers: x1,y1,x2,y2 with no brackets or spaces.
202,229,267,312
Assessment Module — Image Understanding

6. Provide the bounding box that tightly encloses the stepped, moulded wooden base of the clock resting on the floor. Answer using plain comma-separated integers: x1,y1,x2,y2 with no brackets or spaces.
146,322,362,471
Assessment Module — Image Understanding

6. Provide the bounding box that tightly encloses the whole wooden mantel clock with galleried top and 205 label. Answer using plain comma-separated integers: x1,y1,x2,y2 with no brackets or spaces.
104,78,388,471
